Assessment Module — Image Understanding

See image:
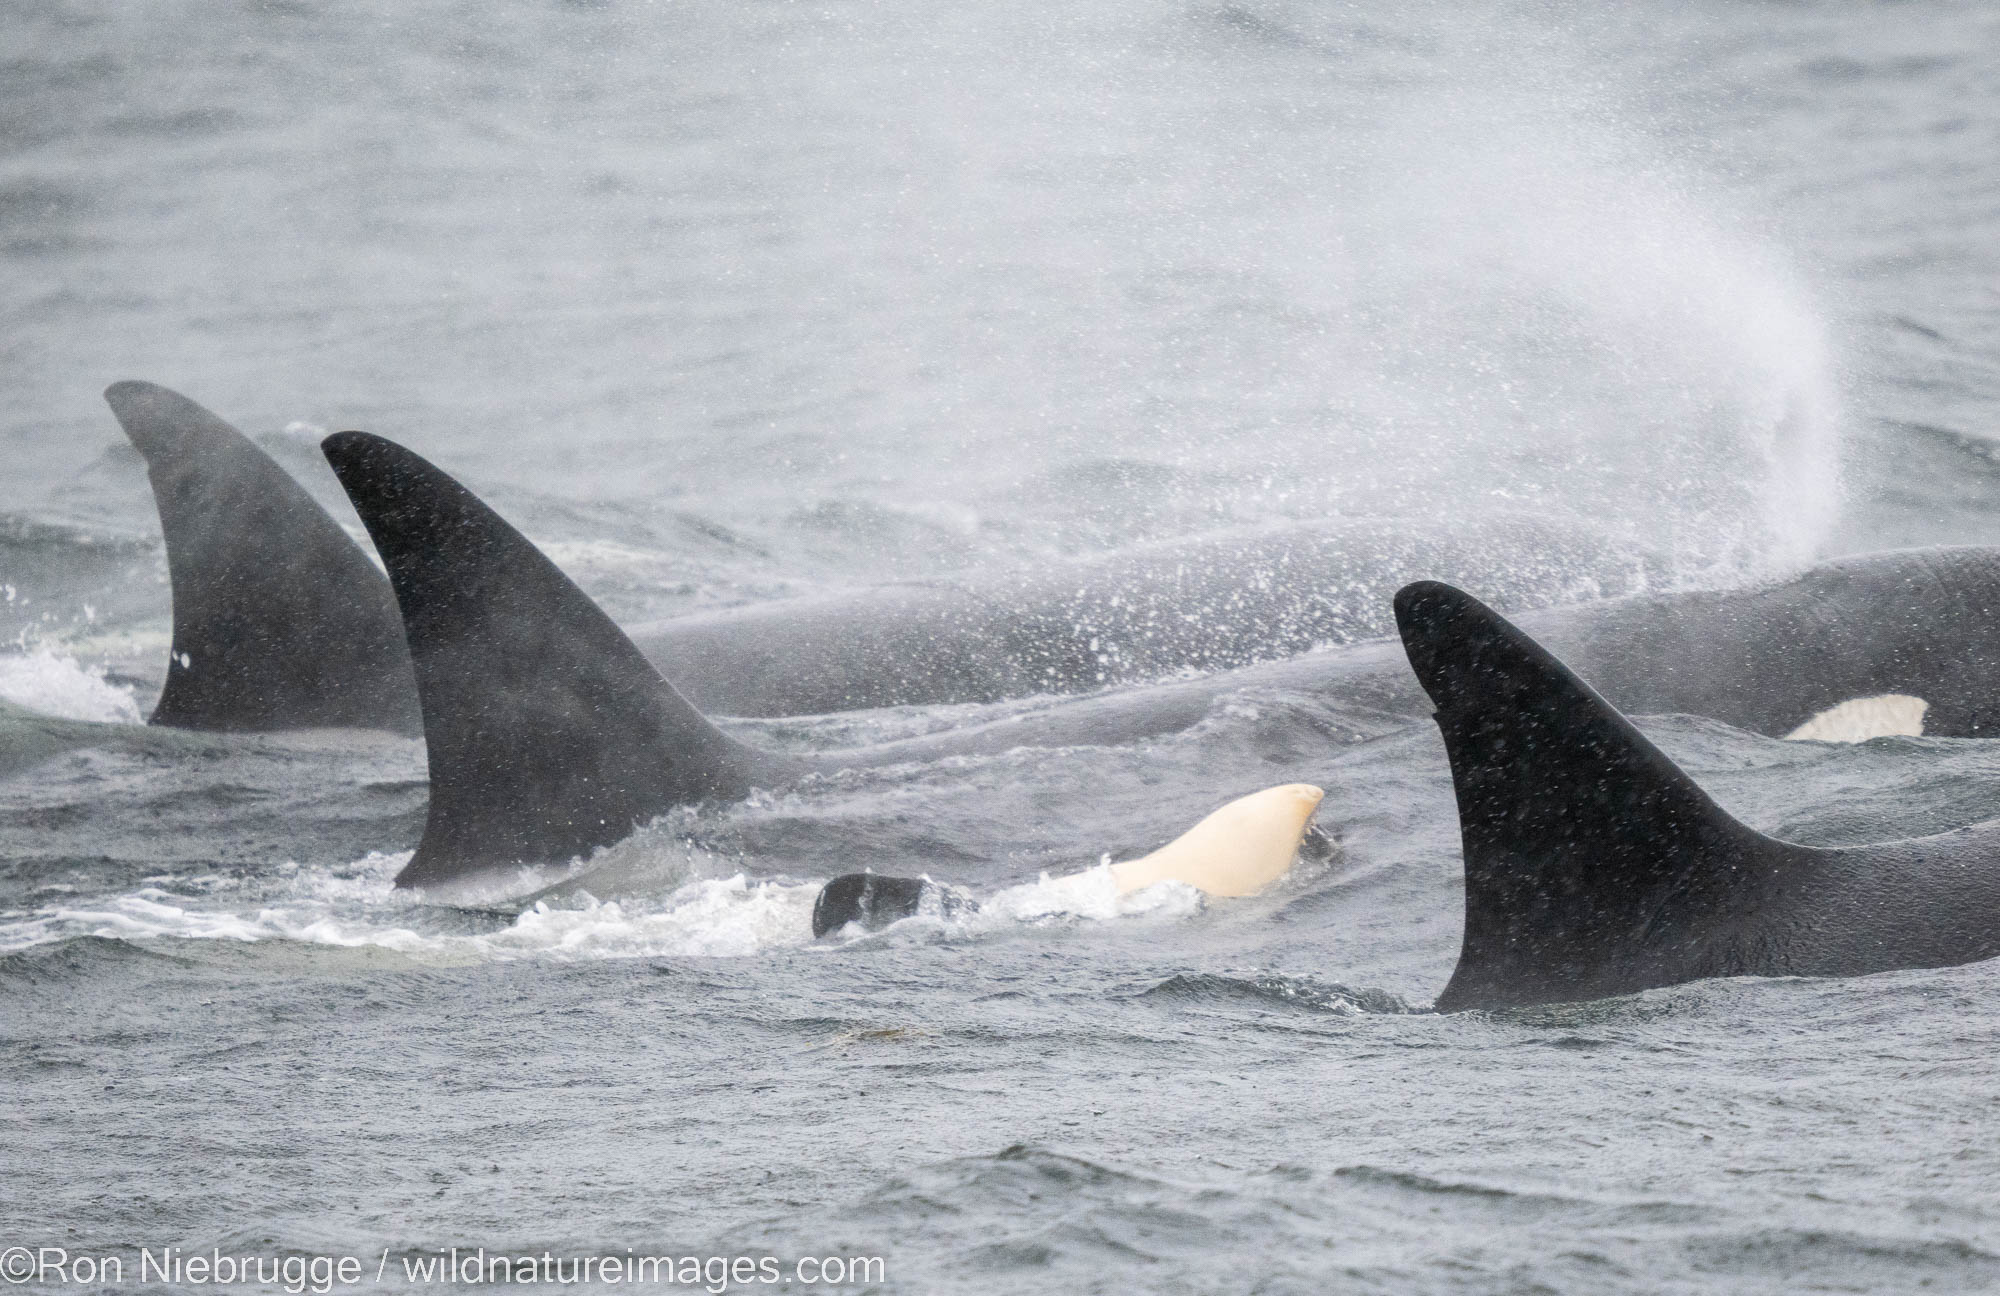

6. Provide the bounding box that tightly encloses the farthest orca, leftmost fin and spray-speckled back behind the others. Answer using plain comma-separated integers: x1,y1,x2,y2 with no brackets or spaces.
106,382,1632,732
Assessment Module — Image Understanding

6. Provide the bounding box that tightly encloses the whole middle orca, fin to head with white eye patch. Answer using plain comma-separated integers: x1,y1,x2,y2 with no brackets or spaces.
312,432,2000,884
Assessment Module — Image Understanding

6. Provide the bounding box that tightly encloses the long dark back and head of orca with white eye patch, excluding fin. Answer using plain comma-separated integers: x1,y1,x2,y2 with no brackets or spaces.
840,546,2000,760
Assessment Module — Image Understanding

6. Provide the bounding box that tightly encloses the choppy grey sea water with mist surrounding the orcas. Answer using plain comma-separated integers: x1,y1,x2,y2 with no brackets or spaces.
0,0,2000,1292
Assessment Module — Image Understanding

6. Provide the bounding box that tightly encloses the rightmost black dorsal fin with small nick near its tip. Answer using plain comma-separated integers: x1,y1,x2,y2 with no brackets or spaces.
1396,582,1810,1012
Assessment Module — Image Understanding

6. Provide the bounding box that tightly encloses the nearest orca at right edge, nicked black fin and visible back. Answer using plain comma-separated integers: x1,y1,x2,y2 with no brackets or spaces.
1396,582,2000,1012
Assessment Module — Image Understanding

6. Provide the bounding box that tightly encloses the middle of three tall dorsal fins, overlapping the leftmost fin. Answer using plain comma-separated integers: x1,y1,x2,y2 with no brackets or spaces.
320,432,800,886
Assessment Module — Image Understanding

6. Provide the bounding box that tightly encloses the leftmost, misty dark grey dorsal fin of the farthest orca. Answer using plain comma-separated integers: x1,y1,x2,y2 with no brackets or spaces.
104,382,422,734
